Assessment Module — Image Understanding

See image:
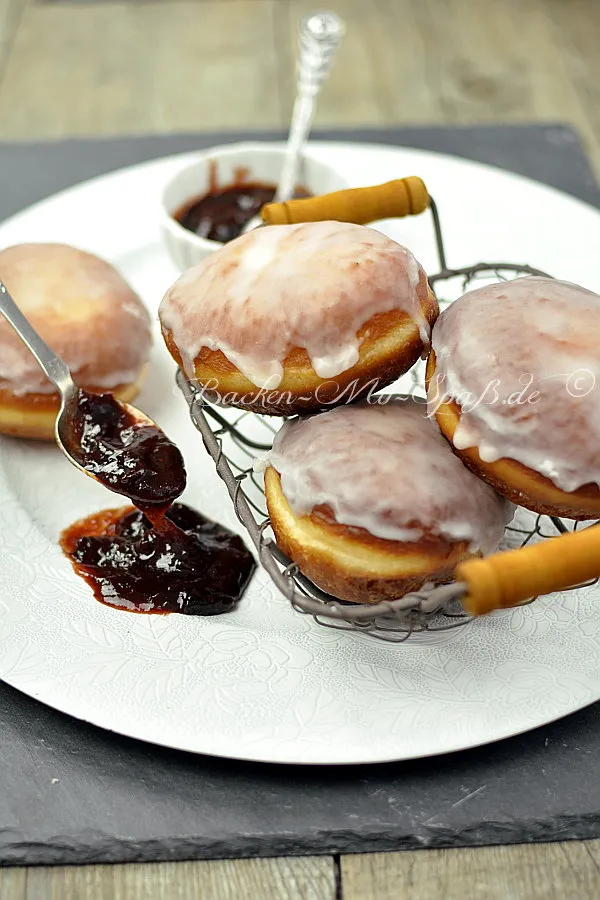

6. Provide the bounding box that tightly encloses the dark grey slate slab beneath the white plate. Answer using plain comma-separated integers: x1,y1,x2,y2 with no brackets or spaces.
0,125,600,865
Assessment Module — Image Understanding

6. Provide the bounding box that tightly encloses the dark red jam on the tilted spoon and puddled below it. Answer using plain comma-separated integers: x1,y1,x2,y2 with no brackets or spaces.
61,391,255,615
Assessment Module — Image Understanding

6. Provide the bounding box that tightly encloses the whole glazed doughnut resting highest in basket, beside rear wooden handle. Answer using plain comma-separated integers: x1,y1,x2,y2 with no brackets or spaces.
159,222,439,415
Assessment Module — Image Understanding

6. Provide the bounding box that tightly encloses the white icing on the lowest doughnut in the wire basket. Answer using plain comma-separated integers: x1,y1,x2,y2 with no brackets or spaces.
266,398,514,554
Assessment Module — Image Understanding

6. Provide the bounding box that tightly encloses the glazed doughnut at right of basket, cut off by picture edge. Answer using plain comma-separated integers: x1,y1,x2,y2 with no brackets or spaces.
428,277,600,519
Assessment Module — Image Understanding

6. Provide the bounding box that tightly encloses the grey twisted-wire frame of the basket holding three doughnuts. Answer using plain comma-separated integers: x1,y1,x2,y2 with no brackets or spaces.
177,199,595,643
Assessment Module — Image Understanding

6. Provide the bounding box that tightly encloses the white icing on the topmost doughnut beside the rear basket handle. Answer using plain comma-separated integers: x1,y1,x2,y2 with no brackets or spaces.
159,222,430,388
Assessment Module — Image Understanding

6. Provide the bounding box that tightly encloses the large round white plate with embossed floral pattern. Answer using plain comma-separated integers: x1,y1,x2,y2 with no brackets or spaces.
0,144,600,764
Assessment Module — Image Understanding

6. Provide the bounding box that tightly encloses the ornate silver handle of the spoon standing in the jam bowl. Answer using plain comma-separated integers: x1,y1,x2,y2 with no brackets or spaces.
274,12,346,203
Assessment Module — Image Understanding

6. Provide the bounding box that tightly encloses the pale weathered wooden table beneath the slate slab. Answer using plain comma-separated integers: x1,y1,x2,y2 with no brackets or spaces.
0,0,600,900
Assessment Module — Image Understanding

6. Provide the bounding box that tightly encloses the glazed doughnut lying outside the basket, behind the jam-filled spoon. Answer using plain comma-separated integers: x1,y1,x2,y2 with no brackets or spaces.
0,244,151,440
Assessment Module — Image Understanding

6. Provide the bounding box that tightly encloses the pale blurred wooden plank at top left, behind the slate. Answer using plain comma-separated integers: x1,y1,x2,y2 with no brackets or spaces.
0,0,282,138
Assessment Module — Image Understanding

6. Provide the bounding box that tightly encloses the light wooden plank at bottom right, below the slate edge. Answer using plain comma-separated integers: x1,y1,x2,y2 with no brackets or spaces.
341,841,600,900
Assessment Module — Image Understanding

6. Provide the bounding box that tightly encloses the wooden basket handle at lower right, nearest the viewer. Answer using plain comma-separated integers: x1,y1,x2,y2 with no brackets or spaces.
455,525,600,616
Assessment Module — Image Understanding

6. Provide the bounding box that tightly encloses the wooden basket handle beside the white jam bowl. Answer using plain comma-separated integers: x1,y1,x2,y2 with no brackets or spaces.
260,175,430,225
